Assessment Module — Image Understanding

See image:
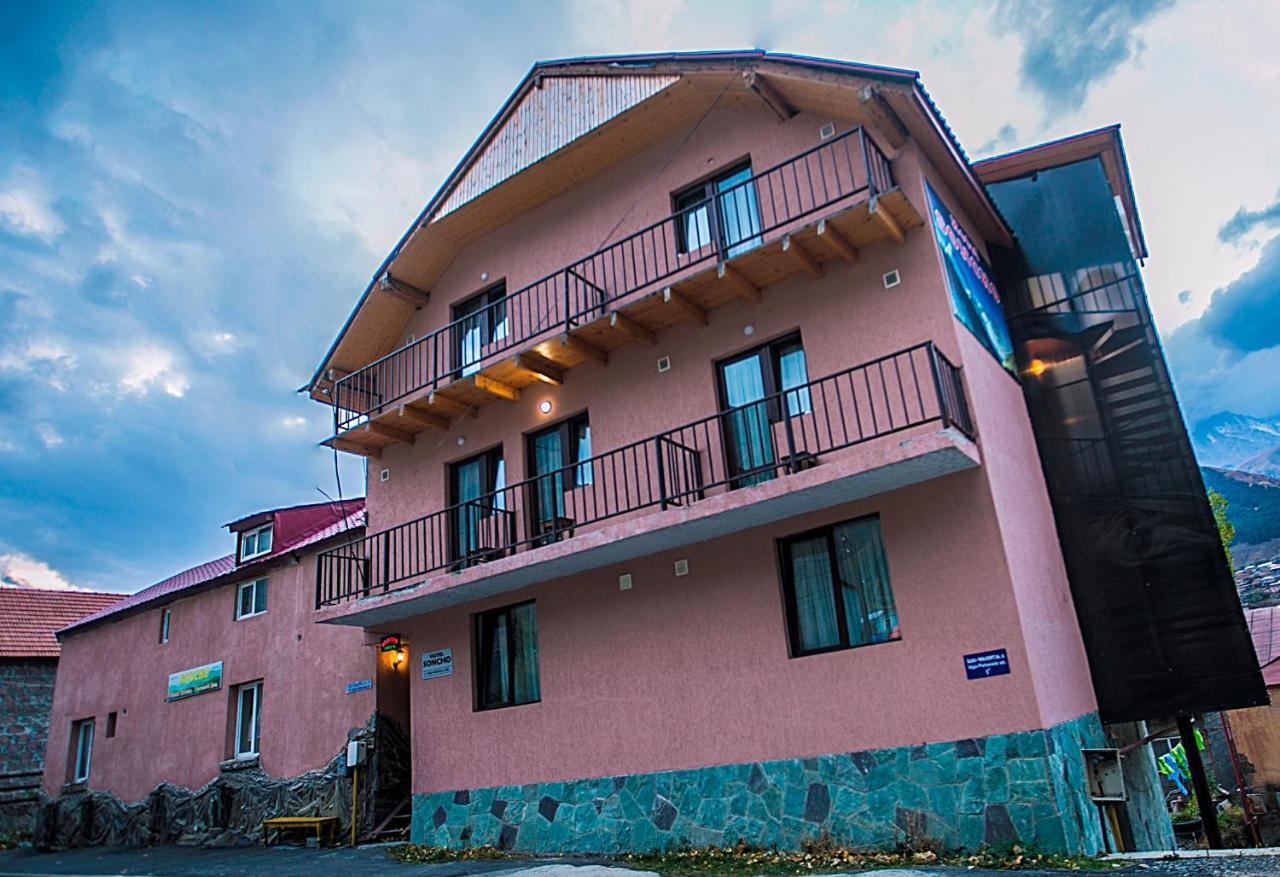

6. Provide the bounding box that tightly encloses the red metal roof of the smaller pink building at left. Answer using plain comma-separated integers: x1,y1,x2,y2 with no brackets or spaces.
58,498,365,638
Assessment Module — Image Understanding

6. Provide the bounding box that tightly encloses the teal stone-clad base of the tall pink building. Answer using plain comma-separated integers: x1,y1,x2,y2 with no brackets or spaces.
412,713,1107,853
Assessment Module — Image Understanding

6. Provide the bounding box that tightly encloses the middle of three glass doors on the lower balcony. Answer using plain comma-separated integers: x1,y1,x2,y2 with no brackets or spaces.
529,414,594,542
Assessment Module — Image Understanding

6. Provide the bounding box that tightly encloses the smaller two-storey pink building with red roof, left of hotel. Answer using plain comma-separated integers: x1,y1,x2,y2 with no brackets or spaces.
40,499,403,845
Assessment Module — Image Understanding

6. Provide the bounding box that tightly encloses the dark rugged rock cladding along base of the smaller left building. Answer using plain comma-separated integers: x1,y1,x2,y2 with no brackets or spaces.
35,716,408,849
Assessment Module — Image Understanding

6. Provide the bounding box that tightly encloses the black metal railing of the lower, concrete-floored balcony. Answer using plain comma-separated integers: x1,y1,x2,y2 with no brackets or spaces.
316,342,973,607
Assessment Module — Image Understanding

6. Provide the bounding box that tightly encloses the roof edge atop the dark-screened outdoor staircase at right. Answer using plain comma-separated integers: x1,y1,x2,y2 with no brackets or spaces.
973,124,1148,259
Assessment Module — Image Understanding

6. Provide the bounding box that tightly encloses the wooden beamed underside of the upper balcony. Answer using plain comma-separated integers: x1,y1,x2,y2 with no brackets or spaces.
324,189,924,457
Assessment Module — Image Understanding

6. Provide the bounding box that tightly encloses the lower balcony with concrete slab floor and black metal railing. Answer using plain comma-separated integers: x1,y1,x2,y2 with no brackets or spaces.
316,342,978,624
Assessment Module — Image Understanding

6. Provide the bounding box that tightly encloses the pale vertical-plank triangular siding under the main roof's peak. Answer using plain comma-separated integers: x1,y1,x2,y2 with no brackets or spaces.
431,74,680,221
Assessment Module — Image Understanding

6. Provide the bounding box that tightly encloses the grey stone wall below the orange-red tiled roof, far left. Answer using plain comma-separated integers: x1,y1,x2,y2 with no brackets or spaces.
0,658,58,839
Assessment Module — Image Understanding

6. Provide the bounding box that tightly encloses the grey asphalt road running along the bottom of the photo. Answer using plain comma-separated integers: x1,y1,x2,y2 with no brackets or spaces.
0,846,1280,877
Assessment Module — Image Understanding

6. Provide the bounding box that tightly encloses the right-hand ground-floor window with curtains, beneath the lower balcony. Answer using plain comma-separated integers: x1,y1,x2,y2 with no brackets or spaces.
780,517,900,657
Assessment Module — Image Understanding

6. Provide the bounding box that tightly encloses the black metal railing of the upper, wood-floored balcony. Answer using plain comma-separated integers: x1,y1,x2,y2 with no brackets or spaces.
333,127,895,433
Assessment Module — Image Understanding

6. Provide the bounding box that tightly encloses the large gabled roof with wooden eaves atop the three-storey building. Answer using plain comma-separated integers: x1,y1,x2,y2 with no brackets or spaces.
302,49,1011,399
